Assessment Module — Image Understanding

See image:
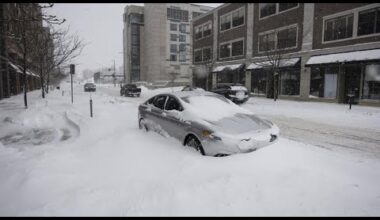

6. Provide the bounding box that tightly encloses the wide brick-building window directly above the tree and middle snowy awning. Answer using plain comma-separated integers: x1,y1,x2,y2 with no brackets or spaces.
259,26,298,52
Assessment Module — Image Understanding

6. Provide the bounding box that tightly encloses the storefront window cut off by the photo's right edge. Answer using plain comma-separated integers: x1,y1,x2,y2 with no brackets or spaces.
363,64,380,100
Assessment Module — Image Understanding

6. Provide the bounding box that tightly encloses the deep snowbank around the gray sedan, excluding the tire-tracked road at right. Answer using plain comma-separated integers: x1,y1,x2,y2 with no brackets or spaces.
0,85,380,216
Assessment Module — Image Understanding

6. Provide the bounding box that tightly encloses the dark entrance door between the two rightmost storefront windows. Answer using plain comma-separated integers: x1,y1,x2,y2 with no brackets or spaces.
343,65,362,104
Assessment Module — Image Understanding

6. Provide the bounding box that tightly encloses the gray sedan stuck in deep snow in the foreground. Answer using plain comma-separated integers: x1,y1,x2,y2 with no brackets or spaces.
138,91,279,156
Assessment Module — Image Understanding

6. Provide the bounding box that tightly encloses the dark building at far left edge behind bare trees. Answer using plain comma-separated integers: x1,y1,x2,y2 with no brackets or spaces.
0,3,43,99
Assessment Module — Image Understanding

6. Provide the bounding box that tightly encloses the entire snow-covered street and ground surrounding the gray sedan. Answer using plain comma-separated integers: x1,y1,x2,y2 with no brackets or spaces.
0,84,380,216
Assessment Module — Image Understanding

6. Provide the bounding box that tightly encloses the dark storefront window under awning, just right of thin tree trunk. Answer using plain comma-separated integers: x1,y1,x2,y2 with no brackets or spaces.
279,68,300,95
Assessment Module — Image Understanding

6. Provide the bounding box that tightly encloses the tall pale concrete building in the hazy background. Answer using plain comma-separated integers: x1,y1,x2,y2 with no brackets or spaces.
123,3,212,82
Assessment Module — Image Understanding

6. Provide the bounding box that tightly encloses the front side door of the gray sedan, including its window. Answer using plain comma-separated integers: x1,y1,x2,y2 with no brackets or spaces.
164,95,188,140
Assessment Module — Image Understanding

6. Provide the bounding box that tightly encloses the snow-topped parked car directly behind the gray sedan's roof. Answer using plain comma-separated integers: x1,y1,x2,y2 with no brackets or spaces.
211,83,249,104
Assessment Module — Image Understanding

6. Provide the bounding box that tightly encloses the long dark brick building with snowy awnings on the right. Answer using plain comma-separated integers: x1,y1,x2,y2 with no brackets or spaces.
192,3,380,105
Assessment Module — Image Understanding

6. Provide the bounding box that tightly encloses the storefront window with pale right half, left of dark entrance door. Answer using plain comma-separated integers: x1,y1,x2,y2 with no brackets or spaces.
310,66,339,98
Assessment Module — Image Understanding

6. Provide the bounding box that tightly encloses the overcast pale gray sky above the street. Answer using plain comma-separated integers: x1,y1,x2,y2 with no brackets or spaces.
48,3,221,73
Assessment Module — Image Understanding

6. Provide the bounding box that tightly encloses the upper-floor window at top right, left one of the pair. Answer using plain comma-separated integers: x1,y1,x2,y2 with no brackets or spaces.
324,14,354,41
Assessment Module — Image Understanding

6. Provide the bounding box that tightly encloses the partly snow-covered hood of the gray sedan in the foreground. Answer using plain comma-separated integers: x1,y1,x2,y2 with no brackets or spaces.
206,113,273,134
